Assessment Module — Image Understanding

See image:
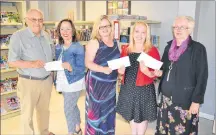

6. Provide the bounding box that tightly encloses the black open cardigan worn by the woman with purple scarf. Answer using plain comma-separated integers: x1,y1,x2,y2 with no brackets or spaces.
159,40,208,109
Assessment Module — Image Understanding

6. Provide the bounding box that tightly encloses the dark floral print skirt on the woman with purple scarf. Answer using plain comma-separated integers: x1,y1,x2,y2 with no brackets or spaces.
155,95,199,135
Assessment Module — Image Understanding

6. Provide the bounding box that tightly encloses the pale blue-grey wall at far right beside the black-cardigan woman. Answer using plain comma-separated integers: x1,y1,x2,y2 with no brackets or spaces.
196,1,216,119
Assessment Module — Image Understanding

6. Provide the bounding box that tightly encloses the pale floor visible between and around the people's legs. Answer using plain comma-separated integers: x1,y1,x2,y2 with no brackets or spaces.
1,90,213,135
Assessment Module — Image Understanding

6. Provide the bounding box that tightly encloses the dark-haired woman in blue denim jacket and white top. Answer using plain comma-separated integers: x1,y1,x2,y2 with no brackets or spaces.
55,19,85,135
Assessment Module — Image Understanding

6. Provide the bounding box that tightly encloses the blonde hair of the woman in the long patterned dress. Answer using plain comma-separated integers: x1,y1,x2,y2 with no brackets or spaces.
91,15,113,40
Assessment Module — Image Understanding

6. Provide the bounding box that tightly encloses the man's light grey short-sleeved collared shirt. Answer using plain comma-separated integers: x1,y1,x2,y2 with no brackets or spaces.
8,28,53,78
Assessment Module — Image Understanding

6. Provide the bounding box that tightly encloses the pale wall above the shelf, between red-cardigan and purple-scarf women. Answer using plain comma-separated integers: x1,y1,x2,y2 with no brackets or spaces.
131,1,178,54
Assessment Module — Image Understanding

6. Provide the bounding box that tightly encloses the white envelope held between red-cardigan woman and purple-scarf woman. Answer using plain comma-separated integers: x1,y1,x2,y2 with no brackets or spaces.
137,52,163,70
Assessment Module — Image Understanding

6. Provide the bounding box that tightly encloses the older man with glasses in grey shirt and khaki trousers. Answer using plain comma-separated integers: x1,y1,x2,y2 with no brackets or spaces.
8,9,54,135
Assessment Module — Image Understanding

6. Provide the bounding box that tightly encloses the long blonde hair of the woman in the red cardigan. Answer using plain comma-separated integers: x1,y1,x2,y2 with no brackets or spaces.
128,21,152,53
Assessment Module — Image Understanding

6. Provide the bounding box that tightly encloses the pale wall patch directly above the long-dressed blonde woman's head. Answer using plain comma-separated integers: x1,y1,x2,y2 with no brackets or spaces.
85,1,106,21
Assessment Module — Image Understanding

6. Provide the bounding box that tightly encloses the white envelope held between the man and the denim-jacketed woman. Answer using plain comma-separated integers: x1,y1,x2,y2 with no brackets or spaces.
44,61,64,71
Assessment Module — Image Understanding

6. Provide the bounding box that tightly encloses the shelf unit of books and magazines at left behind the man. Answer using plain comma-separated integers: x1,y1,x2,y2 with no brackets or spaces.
0,1,26,119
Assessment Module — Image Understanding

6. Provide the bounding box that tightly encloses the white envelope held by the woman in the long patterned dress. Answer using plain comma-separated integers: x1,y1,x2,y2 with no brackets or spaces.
107,56,130,70
